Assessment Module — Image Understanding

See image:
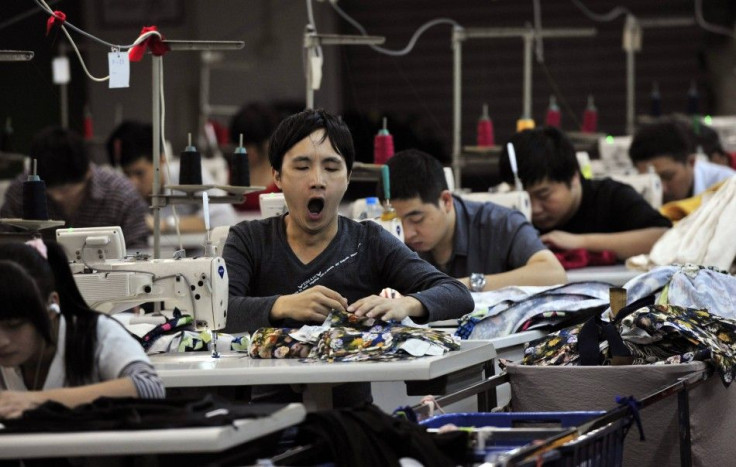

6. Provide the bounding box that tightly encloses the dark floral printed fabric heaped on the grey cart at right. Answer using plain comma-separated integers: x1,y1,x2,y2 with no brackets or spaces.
521,305,736,386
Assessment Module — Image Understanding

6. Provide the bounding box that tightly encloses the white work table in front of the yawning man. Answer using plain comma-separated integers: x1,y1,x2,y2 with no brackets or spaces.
151,341,496,410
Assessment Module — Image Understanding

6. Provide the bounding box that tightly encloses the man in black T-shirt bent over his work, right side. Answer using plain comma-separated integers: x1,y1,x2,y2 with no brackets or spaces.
499,127,671,260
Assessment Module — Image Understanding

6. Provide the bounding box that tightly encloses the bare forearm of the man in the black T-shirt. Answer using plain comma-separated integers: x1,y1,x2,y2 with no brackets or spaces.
541,227,667,260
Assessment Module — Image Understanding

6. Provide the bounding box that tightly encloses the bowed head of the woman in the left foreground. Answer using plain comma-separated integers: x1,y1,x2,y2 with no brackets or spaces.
0,240,58,366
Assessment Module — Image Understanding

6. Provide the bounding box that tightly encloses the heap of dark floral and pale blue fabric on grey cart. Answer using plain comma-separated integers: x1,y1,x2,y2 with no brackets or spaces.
522,265,736,386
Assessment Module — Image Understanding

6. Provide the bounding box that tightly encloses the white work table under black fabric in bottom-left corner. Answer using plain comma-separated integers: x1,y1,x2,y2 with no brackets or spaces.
0,404,306,459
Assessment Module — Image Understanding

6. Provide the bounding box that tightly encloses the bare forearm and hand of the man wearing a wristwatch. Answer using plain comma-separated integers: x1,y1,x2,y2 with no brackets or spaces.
459,250,567,291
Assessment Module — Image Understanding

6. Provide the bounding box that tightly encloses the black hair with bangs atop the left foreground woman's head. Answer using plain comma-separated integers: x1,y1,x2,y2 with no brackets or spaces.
0,259,52,343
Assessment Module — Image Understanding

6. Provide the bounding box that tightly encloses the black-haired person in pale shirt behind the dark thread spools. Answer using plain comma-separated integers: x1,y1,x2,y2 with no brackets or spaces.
106,121,237,232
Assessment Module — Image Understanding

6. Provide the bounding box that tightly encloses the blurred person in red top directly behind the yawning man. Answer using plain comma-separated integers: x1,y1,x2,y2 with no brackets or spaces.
230,102,279,211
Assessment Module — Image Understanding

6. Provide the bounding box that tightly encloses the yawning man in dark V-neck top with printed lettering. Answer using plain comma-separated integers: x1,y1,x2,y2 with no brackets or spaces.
222,109,473,406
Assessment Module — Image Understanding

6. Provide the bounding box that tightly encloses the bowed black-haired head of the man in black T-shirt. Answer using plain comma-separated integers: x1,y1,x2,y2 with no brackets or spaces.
499,127,582,231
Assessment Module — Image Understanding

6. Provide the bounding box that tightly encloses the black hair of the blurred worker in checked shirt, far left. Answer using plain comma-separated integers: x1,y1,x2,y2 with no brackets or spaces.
31,126,89,187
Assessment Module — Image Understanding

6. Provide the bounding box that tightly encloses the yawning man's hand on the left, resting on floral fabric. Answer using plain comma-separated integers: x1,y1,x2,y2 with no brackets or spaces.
271,285,348,323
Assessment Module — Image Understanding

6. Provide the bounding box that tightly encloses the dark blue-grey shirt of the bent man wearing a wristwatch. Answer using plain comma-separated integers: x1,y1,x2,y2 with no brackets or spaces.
419,195,547,277
